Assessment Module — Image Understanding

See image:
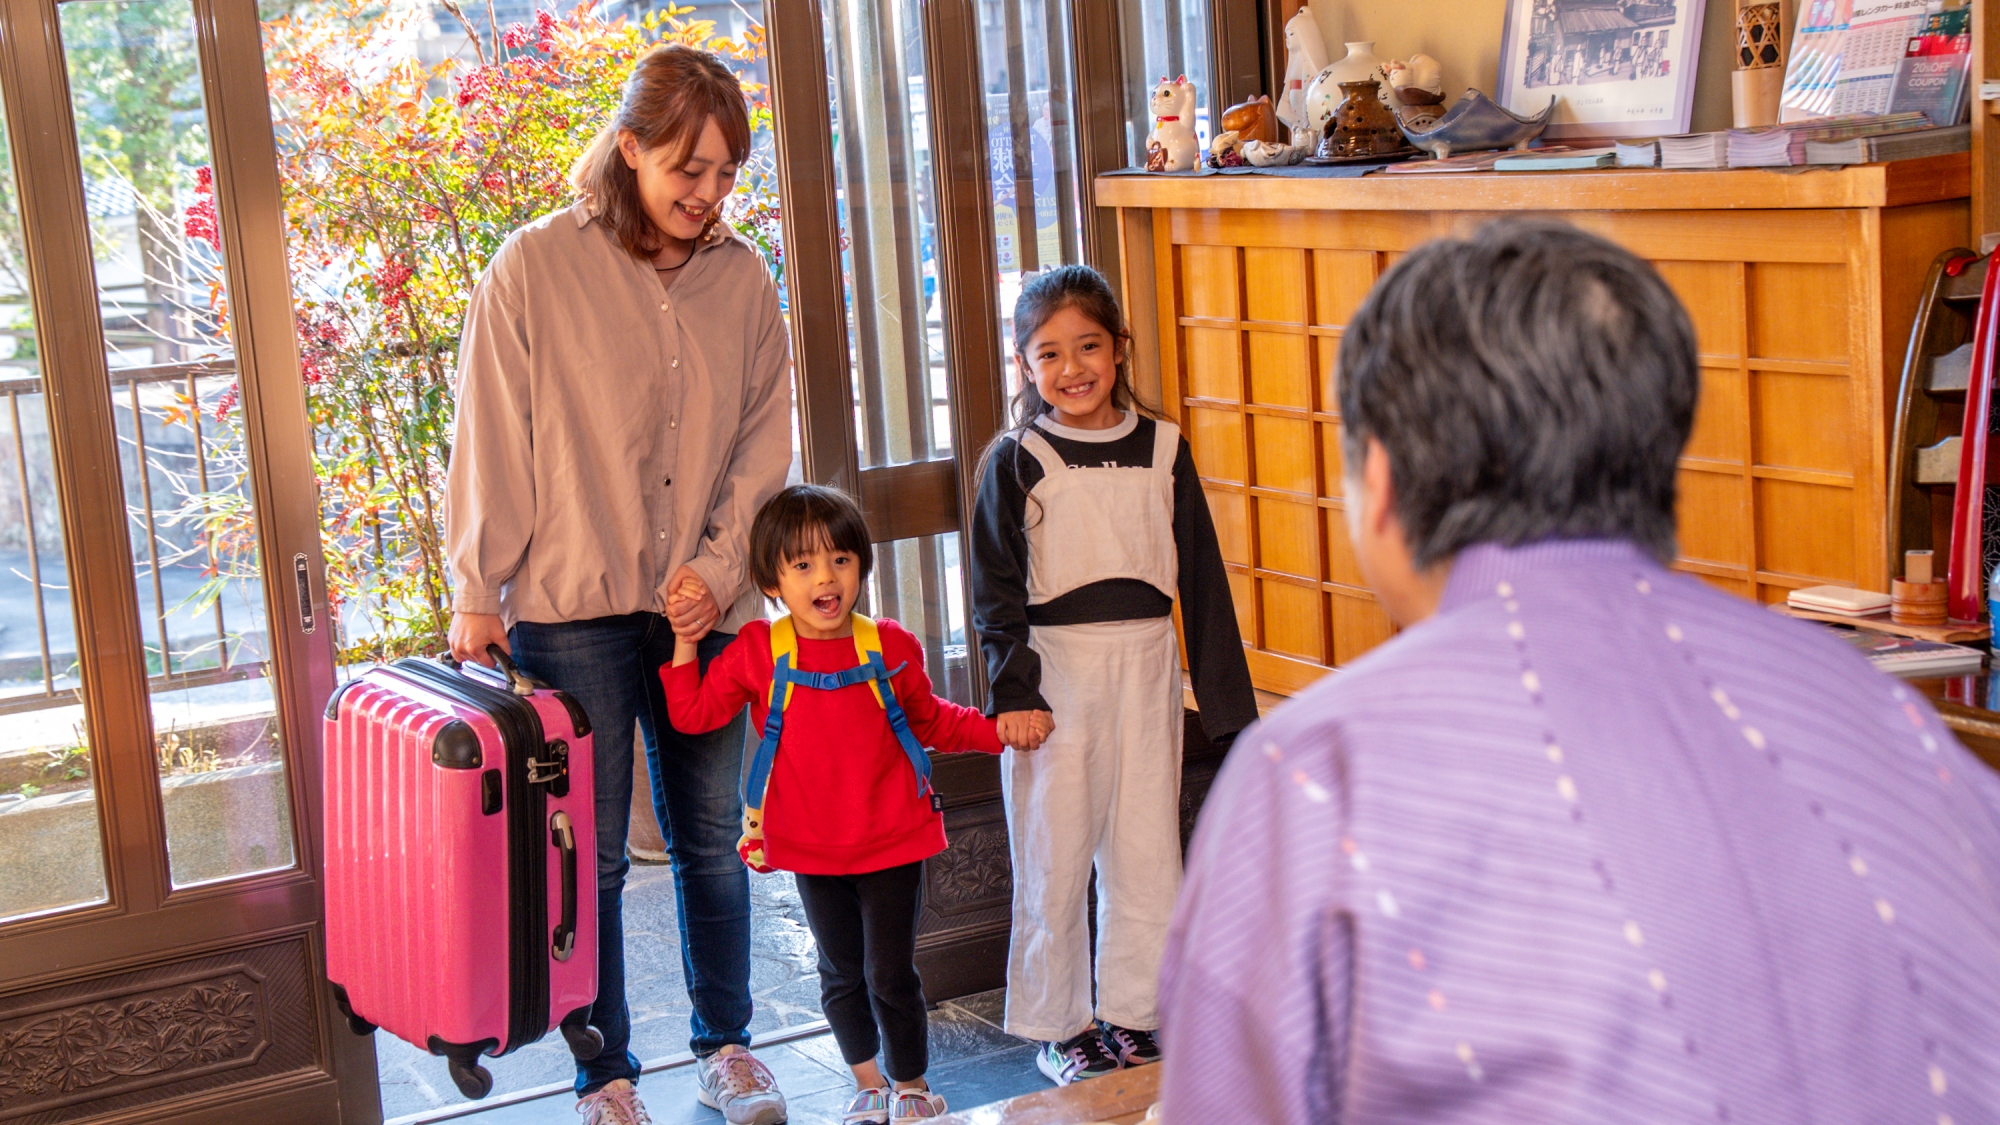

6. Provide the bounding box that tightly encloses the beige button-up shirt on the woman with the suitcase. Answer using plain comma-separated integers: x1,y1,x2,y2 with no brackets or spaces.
444,202,792,633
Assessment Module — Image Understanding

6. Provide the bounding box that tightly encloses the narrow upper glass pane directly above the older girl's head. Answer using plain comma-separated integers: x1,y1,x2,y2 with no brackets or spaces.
980,0,1082,396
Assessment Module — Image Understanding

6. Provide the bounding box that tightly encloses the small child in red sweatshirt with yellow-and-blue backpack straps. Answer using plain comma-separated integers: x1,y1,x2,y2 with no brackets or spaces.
662,484,1024,1125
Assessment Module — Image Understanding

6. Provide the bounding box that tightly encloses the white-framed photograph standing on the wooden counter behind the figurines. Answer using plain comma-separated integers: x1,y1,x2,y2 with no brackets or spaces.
1494,0,1708,138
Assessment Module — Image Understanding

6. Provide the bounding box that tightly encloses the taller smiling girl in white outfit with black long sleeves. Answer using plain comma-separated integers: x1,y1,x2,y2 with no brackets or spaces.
972,266,1256,1085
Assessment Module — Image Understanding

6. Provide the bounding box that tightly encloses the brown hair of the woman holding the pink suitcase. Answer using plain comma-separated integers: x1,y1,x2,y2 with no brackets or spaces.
570,44,750,258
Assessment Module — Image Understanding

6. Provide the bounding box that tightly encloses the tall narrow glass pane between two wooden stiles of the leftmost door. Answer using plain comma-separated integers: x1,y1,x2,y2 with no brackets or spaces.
60,0,294,887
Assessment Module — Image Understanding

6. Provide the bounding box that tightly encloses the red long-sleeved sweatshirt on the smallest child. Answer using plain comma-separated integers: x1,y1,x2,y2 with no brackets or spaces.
660,619,1002,875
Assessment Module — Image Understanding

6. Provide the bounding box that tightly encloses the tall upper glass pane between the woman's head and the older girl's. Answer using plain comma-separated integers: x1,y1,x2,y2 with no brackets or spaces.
822,0,952,468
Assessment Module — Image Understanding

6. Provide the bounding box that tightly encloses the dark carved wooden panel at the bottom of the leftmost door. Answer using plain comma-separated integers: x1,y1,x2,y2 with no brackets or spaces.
0,937,320,1125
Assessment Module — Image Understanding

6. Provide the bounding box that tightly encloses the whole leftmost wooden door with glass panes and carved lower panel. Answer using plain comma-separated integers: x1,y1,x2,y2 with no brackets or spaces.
0,0,380,1123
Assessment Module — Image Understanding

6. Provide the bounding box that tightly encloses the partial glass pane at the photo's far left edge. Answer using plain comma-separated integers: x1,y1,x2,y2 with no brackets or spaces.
0,103,104,921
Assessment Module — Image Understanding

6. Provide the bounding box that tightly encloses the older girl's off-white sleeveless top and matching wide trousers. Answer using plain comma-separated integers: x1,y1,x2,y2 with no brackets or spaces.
1000,422,1182,1041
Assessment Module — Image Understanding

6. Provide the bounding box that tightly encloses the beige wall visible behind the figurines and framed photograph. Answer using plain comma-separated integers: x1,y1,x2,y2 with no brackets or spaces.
1310,0,1760,132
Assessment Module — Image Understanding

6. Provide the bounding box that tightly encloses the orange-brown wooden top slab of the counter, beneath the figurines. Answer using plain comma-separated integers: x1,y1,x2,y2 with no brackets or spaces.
1096,152,1972,210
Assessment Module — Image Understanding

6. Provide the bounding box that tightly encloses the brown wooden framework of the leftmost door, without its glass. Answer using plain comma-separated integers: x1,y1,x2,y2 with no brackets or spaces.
0,0,382,1125
